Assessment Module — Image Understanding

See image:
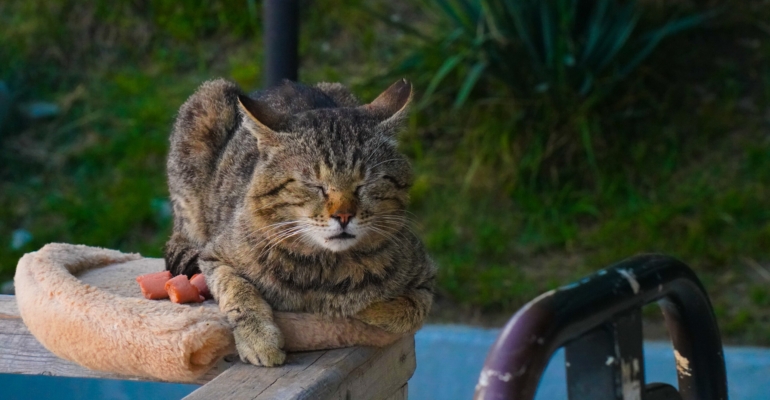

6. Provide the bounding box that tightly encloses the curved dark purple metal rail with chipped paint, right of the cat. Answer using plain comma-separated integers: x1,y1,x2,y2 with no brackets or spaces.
474,255,727,400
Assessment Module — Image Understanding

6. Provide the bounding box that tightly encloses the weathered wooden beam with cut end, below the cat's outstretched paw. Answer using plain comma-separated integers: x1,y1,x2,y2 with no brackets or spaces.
185,336,415,400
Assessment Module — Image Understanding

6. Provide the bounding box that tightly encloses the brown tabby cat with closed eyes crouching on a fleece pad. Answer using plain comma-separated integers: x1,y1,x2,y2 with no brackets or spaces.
165,80,435,366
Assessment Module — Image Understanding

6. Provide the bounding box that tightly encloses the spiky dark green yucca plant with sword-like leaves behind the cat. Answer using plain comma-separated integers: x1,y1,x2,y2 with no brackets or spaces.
402,0,711,107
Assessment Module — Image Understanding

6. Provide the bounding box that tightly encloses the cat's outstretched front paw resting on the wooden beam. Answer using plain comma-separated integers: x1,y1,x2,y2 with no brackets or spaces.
233,322,286,367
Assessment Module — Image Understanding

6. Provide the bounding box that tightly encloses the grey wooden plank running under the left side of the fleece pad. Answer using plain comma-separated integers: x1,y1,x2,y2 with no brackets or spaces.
0,295,228,384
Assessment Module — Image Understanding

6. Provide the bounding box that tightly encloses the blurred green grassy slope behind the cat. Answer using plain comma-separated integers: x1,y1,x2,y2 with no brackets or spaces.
0,0,770,345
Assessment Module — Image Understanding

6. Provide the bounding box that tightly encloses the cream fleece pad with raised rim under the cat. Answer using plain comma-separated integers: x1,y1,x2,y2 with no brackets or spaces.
14,243,398,382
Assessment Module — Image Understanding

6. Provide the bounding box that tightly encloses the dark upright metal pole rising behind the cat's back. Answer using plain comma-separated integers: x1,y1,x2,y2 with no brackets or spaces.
264,0,299,87
